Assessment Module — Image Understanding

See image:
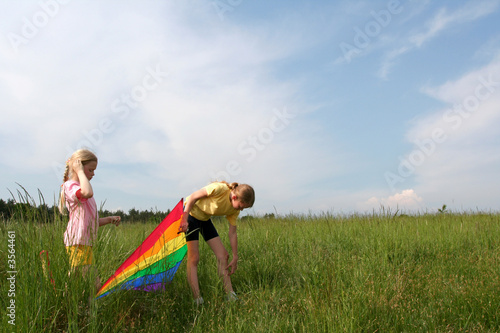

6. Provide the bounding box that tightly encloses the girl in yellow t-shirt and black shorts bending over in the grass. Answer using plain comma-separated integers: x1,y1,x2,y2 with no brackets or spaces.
179,182,255,305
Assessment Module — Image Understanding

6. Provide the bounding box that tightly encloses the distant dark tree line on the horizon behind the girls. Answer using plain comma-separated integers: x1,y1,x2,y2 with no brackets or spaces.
0,199,170,223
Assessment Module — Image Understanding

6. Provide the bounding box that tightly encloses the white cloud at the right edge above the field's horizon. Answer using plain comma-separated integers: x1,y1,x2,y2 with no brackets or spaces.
394,57,500,208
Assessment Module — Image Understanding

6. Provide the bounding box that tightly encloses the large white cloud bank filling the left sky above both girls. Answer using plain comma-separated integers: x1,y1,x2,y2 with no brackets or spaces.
0,2,340,213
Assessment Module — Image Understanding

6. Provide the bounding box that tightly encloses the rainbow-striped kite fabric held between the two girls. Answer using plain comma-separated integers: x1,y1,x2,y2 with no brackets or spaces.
96,199,187,298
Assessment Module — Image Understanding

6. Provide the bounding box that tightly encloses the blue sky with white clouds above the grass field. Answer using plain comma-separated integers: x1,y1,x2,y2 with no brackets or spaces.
0,0,500,214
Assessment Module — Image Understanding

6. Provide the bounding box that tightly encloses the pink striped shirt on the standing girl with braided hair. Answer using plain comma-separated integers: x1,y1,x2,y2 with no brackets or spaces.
63,180,99,246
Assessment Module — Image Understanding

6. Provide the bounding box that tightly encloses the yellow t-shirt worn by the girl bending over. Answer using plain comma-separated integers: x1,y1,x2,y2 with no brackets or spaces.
186,183,240,226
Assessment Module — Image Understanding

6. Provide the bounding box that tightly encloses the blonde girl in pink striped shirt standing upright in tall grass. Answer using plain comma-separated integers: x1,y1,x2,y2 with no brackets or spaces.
59,149,121,278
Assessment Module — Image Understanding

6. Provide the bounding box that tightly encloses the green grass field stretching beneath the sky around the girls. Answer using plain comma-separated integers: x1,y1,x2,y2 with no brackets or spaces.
0,205,500,332
